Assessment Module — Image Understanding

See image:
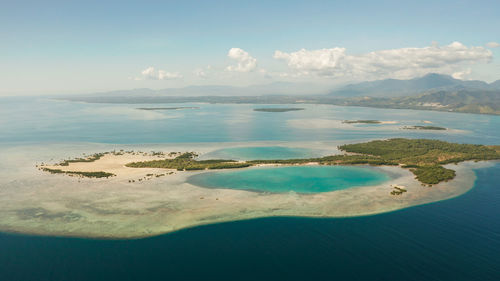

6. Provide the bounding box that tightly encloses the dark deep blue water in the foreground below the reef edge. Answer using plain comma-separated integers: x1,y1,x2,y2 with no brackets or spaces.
0,164,500,281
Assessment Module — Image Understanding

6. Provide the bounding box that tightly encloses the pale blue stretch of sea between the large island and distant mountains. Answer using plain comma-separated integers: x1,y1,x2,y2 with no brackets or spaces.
0,97,500,144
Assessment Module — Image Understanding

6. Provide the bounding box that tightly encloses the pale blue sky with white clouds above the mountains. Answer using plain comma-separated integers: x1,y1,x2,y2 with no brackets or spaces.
0,0,500,96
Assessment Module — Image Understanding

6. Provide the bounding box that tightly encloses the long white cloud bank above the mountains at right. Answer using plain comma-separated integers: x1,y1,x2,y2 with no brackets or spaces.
274,42,492,78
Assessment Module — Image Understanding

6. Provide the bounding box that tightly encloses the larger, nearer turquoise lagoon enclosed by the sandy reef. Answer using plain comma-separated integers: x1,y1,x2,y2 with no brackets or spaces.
187,166,390,193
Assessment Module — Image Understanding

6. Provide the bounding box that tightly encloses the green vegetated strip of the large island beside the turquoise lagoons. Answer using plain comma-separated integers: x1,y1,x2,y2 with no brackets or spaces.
40,138,500,186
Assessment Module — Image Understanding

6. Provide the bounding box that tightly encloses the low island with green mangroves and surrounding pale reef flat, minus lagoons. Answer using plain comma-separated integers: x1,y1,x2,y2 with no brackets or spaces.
0,139,499,239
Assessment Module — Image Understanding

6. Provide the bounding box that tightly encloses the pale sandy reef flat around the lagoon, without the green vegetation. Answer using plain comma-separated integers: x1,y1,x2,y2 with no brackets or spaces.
0,141,488,239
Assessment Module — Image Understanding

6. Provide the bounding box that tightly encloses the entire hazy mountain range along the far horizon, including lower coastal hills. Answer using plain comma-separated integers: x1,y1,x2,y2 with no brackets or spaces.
64,74,500,115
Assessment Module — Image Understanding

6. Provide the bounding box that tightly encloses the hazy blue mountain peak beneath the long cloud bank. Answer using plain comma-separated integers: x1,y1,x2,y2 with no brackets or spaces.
330,73,492,97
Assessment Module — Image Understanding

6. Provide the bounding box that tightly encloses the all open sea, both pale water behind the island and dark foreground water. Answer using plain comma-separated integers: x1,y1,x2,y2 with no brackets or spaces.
0,98,500,281
